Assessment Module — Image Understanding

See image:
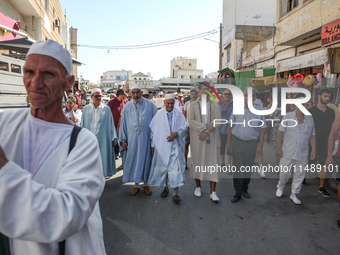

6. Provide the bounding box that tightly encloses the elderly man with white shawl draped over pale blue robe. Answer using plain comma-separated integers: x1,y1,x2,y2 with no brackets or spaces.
149,94,187,202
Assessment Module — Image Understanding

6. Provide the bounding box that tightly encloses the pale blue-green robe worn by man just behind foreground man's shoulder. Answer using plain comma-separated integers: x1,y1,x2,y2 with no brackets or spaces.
81,104,118,177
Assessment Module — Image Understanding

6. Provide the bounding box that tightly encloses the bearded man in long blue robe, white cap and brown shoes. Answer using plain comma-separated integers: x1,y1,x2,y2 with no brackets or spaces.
119,84,157,196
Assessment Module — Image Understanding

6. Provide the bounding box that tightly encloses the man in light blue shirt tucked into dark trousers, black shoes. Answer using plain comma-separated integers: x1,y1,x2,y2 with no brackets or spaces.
228,87,267,203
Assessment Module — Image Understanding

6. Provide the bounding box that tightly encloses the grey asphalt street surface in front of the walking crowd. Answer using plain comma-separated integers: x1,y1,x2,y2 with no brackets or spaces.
100,143,340,255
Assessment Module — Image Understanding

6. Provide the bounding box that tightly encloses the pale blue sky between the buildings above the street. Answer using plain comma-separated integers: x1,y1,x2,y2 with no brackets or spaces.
60,0,223,82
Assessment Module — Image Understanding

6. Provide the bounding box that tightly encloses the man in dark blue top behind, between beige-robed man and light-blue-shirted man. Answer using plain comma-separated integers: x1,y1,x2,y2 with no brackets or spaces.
219,89,233,170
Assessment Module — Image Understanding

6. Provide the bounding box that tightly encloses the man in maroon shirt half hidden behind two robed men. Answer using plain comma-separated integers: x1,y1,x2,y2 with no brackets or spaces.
107,89,126,170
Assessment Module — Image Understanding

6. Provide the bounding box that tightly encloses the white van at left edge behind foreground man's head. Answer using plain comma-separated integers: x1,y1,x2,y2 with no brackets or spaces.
0,55,30,111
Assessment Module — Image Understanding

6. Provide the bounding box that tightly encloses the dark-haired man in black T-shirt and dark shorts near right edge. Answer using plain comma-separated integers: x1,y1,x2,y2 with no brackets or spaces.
309,89,335,197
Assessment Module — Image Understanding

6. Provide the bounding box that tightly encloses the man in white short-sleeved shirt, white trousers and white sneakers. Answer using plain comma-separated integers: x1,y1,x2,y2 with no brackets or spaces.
276,100,316,205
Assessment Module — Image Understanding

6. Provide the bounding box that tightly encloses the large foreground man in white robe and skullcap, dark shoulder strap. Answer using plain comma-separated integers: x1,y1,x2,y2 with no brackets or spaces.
0,40,106,255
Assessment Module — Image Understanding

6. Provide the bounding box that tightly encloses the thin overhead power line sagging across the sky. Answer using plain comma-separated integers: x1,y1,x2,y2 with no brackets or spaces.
77,29,218,50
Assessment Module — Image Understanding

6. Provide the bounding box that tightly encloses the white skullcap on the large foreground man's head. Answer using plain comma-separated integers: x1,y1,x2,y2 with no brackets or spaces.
26,39,72,74
